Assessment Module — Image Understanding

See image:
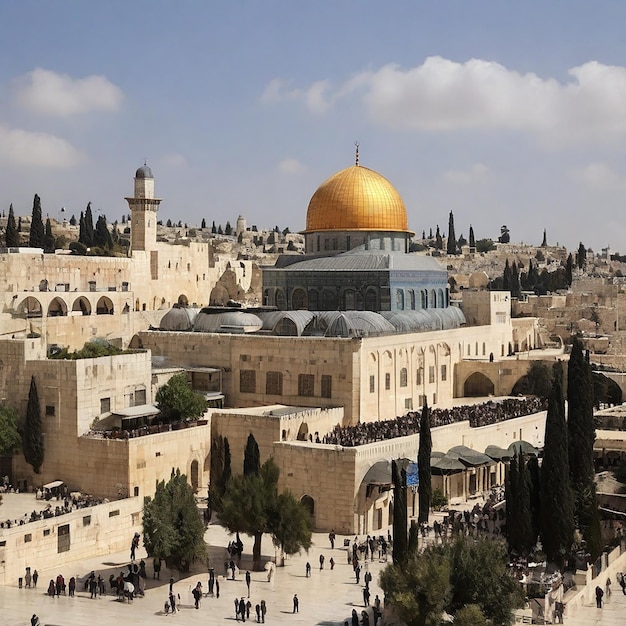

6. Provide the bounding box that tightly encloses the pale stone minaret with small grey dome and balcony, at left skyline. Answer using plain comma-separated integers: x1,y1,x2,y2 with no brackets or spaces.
125,163,161,252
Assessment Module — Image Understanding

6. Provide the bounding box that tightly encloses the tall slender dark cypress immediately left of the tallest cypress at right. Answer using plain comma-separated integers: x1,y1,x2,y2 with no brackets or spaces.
541,363,574,565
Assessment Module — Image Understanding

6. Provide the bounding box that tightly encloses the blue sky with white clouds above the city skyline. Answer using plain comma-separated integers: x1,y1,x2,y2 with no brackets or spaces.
0,0,626,252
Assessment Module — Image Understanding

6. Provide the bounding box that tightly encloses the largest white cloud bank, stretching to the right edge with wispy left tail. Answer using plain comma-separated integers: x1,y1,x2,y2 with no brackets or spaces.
266,56,626,139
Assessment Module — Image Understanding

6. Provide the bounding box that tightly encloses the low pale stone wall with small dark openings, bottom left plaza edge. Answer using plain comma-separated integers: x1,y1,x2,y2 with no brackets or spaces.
0,498,143,586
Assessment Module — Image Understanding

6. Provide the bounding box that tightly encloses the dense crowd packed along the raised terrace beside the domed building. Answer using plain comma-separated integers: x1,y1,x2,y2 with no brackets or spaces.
316,396,547,447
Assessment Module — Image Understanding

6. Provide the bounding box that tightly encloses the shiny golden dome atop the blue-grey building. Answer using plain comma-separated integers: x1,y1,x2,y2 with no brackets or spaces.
305,165,409,232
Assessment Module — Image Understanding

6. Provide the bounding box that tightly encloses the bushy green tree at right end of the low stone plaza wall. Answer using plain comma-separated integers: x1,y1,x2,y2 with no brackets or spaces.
143,469,206,572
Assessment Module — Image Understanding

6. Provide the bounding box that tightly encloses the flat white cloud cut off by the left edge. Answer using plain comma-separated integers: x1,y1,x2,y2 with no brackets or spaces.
0,126,84,169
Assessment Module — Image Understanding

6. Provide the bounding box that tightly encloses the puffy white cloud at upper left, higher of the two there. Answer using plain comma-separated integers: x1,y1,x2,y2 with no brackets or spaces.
15,68,124,117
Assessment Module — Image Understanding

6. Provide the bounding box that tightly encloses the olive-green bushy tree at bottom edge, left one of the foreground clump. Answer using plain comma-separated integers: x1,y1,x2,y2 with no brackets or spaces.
379,546,450,626
